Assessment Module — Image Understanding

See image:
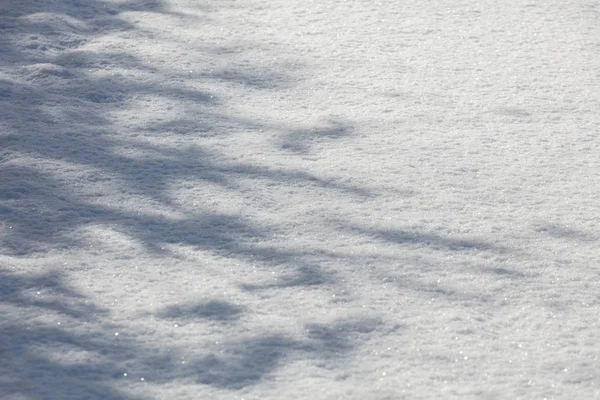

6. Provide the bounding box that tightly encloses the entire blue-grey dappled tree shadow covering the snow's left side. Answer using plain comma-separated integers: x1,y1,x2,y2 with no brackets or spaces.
0,0,404,399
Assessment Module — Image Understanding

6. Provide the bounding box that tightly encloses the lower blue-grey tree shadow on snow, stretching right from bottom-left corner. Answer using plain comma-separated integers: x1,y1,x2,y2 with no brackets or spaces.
0,260,401,400
